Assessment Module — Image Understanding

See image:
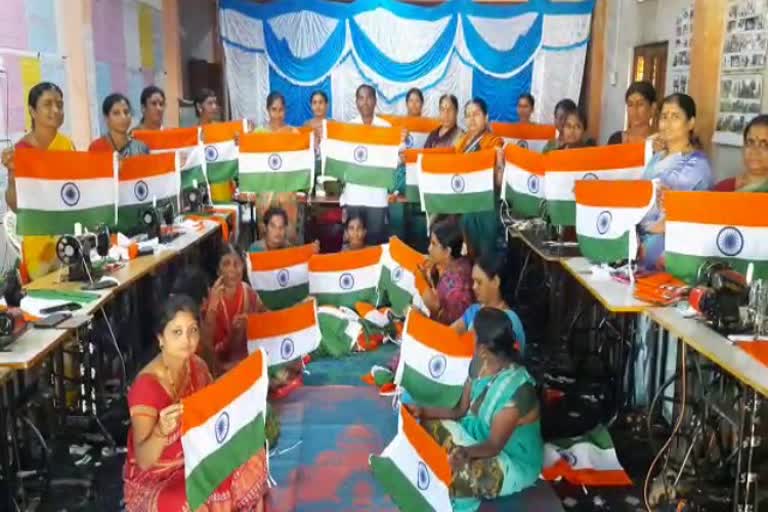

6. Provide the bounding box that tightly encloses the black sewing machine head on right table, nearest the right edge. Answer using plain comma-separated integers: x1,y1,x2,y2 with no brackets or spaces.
689,262,749,334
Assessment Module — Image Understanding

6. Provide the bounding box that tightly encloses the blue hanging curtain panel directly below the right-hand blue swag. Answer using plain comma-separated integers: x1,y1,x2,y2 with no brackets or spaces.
472,62,533,123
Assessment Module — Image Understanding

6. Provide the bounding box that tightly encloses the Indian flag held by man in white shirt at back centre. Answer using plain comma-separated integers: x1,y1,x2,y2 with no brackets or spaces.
321,121,402,188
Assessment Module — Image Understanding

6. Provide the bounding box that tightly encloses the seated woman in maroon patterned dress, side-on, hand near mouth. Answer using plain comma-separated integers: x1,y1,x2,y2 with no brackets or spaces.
422,220,474,325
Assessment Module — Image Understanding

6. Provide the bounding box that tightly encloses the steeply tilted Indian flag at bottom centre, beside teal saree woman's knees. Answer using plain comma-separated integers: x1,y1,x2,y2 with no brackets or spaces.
369,407,453,512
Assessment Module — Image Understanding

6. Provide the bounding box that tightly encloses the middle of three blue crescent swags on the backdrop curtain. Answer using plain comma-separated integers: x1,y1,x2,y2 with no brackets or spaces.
349,16,458,82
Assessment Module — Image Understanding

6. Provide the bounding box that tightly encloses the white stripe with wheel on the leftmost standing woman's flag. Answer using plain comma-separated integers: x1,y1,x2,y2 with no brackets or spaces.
16,178,116,212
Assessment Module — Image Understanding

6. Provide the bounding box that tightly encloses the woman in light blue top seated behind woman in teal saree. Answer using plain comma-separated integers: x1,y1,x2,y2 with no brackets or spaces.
451,253,525,354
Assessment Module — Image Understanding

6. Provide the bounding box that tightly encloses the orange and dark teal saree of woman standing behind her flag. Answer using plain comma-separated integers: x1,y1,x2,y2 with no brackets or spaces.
455,131,504,258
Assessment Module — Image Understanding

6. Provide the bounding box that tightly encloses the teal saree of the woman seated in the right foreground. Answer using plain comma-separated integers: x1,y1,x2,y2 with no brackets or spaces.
424,366,544,512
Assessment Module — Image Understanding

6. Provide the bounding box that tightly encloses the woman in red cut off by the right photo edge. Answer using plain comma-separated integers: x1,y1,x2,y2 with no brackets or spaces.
715,114,768,192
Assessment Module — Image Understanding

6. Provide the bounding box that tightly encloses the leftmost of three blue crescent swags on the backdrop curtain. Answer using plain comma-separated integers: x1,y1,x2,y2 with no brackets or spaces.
264,16,346,82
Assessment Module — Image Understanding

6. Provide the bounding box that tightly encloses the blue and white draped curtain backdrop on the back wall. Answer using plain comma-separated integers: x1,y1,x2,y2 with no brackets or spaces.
219,0,594,125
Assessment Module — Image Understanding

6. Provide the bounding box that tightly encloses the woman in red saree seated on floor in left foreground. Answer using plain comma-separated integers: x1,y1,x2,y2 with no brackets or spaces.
123,295,268,512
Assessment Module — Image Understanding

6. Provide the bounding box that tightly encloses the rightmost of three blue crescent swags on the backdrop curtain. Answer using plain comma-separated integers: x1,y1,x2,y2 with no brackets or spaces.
461,14,544,73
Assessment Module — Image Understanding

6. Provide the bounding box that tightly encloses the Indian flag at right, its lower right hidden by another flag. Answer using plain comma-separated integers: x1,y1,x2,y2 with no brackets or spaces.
544,144,645,226
